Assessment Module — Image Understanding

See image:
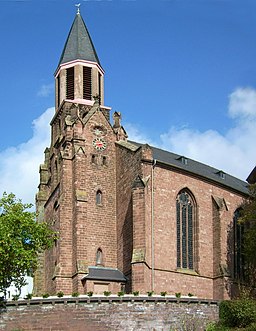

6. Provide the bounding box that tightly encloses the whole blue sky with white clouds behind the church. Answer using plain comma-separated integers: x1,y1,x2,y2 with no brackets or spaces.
0,0,256,201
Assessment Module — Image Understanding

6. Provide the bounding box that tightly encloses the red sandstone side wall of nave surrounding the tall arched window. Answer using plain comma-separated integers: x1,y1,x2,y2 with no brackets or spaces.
143,165,246,299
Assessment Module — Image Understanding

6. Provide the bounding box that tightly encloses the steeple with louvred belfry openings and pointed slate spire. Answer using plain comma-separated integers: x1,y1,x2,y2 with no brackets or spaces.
55,8,104,111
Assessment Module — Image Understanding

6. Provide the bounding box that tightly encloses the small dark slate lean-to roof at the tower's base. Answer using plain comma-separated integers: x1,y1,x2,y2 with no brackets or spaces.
83,267,127,282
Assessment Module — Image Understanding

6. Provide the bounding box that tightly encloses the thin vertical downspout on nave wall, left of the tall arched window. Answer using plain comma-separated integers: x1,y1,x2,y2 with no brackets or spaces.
151,159,156,291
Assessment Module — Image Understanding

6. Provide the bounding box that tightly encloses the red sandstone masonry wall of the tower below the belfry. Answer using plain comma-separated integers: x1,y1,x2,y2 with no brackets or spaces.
38,104,120,294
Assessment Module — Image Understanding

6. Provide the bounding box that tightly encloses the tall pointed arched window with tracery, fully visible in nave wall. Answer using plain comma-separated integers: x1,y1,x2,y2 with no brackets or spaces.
176,190,195,269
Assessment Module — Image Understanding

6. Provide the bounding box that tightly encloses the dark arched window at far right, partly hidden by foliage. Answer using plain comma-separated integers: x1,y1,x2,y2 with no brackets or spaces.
233,209,245,280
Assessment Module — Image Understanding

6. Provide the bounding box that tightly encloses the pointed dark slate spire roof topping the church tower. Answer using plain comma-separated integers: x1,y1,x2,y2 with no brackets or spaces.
58,12,100,66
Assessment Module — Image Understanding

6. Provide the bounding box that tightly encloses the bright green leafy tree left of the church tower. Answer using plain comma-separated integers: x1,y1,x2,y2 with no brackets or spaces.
0,193,56,293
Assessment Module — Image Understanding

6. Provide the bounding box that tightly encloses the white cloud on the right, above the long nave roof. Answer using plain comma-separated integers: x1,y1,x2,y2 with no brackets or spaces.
160,88,256,180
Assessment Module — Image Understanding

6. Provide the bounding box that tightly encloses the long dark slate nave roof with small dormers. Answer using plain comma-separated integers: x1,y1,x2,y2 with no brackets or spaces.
118,141,248,194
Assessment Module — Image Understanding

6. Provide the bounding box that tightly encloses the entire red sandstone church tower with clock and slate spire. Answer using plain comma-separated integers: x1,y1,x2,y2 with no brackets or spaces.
34,10,126,294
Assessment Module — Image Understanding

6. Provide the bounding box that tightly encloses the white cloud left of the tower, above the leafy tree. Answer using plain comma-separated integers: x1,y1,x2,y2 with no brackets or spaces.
0,108,54,203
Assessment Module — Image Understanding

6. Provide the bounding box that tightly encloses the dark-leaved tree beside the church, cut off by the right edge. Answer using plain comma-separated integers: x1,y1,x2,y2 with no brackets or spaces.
240,184,256,294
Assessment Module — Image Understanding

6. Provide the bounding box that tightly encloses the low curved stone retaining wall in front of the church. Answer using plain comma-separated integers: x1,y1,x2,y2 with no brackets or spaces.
0,296,219,331
